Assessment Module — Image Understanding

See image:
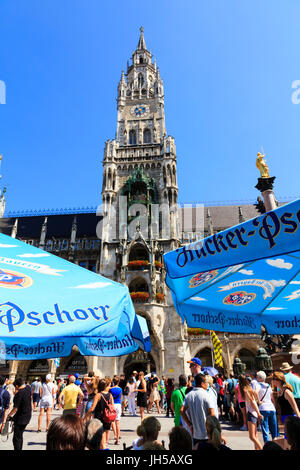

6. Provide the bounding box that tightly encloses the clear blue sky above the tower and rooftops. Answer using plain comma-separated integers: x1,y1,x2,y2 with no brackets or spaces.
0,0,300,215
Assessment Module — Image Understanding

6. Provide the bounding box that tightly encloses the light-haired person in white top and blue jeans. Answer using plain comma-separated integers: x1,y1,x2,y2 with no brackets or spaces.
256,370,278,443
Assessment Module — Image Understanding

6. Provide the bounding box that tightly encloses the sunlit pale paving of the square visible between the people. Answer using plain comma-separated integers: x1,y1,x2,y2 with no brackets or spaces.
0,410,263,451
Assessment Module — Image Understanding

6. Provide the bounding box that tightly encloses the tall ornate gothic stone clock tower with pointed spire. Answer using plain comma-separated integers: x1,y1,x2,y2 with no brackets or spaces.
99,28,189,377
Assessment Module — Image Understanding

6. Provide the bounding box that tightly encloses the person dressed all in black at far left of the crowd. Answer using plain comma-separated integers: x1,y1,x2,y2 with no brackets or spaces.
7,377,32,450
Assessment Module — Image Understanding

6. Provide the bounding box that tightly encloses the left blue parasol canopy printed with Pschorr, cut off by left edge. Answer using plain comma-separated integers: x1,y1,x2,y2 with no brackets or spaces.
0,234,151,360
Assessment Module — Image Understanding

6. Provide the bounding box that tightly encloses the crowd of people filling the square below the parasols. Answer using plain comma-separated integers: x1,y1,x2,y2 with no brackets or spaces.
0,357,300,452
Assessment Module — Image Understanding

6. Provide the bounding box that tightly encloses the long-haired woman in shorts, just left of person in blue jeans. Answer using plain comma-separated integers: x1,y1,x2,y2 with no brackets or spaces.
239,375,263,450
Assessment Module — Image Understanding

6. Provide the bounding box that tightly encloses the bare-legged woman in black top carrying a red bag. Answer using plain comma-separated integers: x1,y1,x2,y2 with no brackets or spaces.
86,377,114,449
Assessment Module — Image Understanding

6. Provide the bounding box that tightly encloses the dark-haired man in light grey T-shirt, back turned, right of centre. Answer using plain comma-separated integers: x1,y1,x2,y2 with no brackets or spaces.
180,374,214,446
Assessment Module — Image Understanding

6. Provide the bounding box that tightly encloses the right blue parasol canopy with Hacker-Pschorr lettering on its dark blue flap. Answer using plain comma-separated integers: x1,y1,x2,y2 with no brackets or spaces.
164,199,300,334
